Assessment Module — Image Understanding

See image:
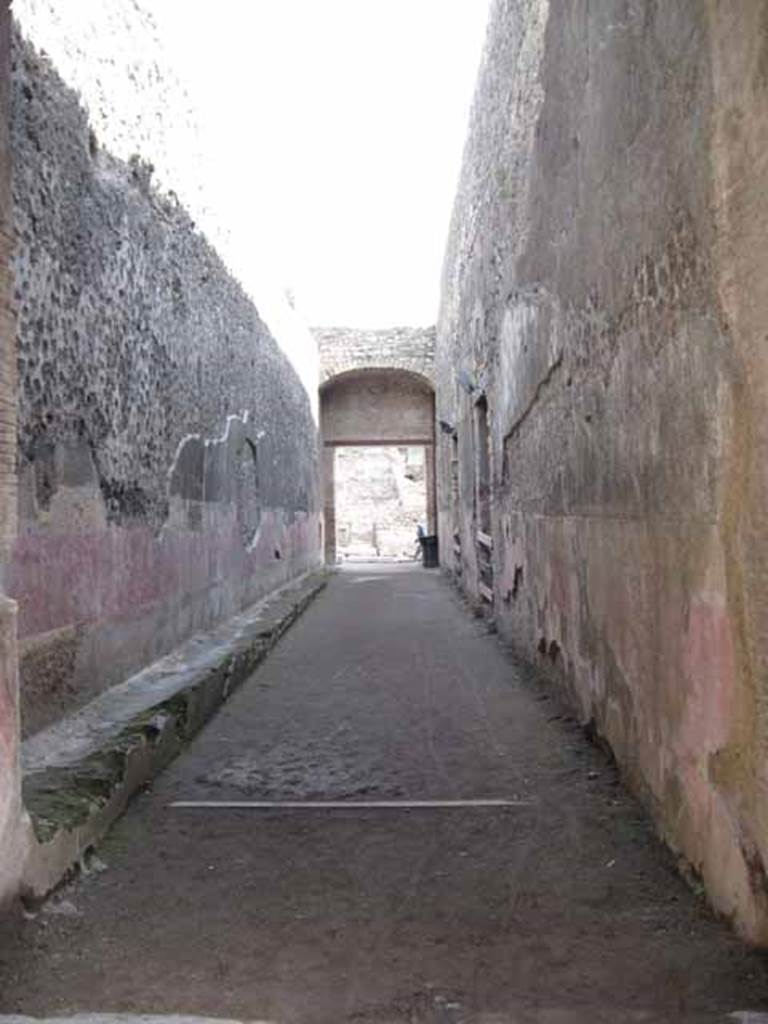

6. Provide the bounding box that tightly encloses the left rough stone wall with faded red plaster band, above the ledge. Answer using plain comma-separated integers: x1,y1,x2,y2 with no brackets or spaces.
8,0,319,732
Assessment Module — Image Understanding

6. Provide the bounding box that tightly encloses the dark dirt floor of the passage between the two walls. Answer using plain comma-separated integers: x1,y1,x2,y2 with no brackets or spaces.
0,565,768,1024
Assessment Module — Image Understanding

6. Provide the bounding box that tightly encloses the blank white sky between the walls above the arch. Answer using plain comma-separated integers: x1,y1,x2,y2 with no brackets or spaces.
150,0,487,327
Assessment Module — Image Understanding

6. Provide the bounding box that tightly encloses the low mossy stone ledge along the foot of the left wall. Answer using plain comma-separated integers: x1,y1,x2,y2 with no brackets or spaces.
23,572,329,901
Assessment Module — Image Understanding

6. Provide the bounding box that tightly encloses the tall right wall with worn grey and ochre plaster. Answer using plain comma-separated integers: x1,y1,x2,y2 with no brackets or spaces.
436,0,768,943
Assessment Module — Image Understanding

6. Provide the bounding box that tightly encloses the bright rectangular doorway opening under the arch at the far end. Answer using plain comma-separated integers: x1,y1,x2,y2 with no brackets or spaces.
334,444,428,561
